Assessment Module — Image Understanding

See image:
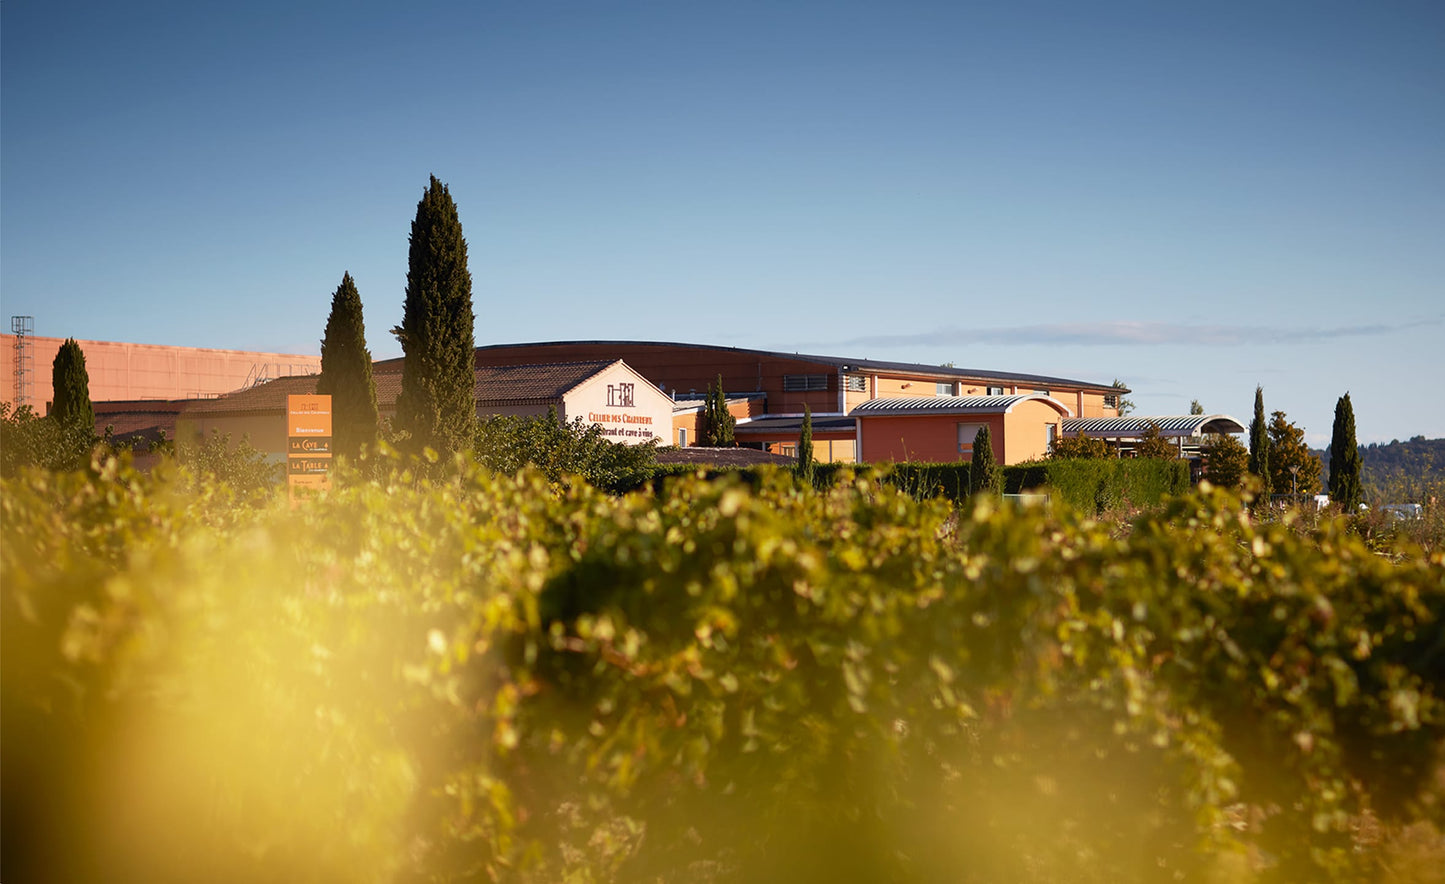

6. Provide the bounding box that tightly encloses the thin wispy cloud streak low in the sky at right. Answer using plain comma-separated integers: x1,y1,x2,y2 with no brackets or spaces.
842,318,1442,347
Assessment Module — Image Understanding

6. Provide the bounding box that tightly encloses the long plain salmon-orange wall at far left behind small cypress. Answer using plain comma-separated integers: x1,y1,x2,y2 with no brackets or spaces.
0,335,321,413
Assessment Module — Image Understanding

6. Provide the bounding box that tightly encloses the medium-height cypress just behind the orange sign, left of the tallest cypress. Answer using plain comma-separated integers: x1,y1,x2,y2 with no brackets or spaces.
316,273,379,456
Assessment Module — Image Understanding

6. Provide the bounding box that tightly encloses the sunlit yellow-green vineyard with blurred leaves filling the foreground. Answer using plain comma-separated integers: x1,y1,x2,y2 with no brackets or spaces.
0,459,1445,883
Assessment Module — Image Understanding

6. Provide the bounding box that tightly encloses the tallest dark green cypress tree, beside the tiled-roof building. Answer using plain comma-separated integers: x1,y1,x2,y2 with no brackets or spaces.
392,175,477,456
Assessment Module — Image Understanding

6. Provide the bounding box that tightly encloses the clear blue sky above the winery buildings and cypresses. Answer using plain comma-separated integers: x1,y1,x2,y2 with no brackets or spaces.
0,0,1445,446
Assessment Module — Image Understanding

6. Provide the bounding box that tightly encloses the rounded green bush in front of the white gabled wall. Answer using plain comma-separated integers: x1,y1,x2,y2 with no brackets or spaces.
474,409,657,493
